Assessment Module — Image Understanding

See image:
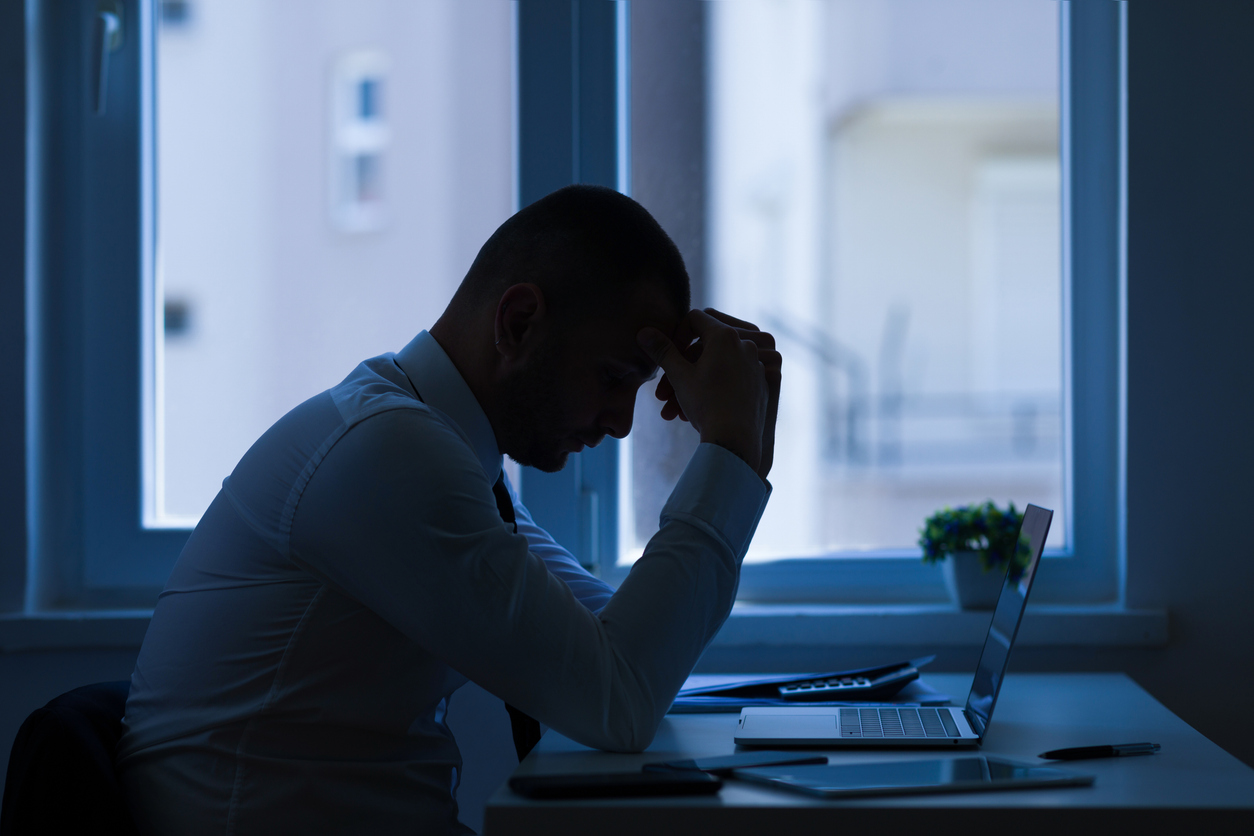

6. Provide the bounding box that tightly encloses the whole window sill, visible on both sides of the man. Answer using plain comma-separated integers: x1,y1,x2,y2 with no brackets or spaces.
0,604,1167,653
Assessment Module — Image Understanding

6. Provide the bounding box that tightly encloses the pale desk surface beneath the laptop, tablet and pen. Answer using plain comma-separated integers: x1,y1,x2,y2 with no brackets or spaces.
484,673,1254,836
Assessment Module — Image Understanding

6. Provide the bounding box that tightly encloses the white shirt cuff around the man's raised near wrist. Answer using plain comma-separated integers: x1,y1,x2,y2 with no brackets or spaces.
661,442,771,562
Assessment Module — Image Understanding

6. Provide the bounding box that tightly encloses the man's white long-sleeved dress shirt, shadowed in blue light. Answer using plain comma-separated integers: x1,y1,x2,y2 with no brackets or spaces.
118,332,767,836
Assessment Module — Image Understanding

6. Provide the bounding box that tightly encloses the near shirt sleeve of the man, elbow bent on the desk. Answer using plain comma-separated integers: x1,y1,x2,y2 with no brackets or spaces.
290,410,767,751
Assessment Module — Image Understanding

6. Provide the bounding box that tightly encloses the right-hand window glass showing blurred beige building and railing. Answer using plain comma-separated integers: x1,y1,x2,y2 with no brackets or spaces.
624,0,1067,560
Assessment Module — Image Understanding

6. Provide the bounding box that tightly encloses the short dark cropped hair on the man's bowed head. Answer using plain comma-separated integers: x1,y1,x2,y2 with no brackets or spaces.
454,185,691,316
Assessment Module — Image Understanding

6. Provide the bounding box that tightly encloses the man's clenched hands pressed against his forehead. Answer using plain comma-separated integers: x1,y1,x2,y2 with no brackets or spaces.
637,308,782,479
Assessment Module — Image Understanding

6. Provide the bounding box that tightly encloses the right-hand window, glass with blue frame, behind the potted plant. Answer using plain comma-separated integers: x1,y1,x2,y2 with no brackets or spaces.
609,0,1121,603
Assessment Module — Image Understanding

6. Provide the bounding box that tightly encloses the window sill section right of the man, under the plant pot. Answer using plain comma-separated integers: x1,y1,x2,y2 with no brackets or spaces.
711,604,1167,649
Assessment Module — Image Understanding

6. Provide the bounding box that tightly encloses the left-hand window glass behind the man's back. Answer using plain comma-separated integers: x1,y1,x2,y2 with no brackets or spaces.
145,0,514,525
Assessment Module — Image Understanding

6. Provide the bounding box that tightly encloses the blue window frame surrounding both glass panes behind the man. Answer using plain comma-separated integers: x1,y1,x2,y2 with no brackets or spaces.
0,0,1126,612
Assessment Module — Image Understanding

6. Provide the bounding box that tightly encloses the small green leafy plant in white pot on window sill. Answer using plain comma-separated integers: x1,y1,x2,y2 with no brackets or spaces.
919,501,1030,609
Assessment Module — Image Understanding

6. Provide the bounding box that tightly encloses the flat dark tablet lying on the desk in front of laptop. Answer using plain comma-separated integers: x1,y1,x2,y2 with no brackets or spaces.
732,756,1093,798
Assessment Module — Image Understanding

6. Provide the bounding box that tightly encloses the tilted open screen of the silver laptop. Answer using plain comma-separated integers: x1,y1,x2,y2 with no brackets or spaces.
967,505,1053,737
